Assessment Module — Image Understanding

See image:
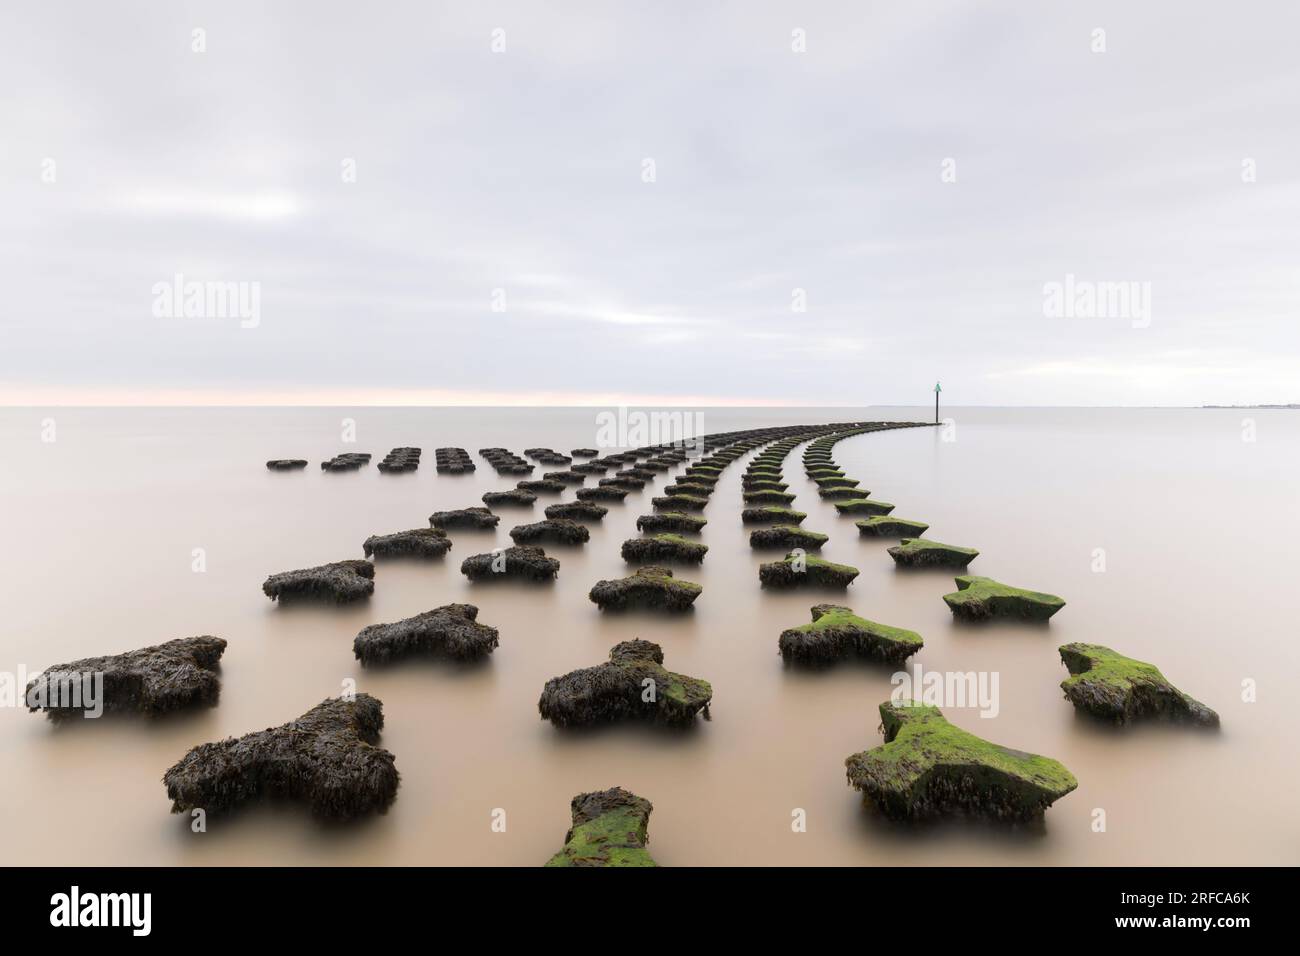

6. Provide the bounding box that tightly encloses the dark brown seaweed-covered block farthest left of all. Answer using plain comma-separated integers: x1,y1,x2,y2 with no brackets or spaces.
25,635,226,719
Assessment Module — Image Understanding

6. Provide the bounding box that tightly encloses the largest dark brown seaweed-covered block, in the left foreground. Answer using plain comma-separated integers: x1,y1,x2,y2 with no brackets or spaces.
163,693,400,819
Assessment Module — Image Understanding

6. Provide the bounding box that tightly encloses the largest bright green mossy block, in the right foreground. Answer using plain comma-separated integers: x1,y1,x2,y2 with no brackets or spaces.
845,701,1079,822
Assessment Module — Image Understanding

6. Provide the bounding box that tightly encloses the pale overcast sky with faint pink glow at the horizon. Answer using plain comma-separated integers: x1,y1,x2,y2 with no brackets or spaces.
0,0,1300,406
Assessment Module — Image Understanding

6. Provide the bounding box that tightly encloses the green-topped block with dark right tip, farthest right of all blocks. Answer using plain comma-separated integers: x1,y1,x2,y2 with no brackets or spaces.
1060,644,1219,727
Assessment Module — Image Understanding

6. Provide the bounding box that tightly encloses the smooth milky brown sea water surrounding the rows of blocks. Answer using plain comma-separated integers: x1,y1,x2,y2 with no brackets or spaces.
0,408,1300,865
